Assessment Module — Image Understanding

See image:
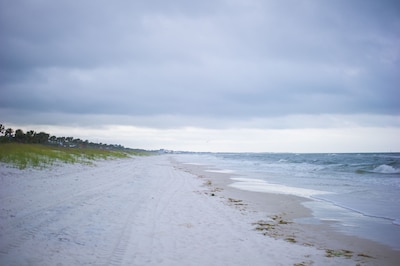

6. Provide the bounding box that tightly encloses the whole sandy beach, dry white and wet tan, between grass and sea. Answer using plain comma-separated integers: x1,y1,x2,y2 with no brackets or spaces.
0,155,400,265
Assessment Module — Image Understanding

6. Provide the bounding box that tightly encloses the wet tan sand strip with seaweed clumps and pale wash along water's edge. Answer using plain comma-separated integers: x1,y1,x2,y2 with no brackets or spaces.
173,158,400,265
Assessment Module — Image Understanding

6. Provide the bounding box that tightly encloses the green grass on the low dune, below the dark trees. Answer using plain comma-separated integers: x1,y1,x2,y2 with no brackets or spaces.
0,143,134,169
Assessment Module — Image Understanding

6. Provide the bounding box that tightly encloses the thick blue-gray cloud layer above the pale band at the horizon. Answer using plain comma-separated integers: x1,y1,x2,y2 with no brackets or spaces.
0,1,400,129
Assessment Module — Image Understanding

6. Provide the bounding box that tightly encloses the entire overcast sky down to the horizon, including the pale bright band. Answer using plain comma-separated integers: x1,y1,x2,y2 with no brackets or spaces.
0,0,400,152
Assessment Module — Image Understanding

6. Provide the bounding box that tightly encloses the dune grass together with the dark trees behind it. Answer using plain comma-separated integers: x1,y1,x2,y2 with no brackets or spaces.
0,124,154,169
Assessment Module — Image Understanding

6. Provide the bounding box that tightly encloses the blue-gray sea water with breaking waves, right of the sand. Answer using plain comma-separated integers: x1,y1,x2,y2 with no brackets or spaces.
177,153,400,250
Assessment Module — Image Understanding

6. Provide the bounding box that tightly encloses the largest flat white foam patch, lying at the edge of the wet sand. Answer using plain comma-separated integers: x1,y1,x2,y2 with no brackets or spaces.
229,177,331,198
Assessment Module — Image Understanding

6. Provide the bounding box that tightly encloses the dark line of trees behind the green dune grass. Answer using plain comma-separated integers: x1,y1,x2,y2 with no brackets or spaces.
0,124,128,150
